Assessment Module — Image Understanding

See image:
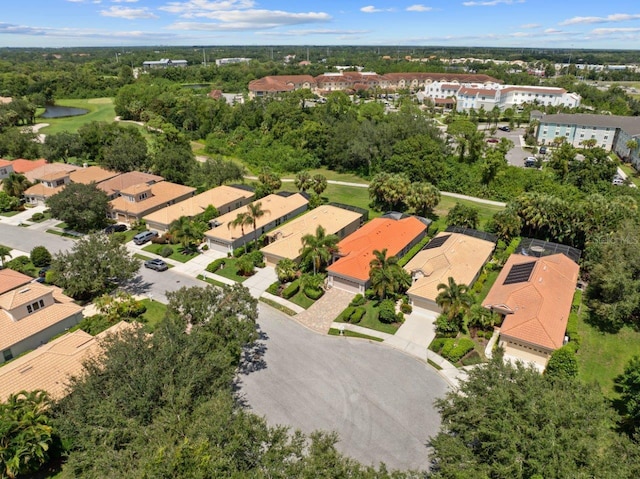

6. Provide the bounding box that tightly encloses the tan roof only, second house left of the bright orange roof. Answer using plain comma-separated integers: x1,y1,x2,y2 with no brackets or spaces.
205,193,308,243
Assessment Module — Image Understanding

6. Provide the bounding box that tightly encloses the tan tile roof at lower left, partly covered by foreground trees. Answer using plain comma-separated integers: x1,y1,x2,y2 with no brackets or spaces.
0,322,134,401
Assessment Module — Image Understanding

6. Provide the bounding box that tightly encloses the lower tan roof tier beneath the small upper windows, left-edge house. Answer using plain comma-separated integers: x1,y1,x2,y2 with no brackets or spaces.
0,303,82,351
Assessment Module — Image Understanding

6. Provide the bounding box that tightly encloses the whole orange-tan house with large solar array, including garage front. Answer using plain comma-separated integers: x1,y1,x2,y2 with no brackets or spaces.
482,253,580,371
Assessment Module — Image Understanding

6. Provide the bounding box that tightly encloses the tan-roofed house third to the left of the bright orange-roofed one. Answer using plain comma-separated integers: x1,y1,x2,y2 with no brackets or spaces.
144,185,255,233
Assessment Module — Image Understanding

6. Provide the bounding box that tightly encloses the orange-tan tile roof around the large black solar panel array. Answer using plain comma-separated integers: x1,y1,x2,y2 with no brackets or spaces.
482,254,579,350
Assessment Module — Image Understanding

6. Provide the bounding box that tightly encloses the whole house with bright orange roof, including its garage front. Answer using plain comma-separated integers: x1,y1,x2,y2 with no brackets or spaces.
327,215,429,293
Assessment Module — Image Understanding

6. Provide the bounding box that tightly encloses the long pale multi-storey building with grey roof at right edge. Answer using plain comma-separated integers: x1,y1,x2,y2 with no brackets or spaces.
536,113,640,168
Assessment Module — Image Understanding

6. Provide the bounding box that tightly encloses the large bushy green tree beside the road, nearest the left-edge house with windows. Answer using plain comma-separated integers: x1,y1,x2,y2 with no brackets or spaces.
51,233,140,299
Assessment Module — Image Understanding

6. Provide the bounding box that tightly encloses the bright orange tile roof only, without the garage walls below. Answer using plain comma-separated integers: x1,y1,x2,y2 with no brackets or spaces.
327,216,427,281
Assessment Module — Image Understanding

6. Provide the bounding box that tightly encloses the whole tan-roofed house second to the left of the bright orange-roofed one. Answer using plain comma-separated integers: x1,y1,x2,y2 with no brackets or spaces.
205,193,309,253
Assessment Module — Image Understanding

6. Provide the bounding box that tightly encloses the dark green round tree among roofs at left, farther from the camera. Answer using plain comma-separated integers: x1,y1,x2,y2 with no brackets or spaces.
47,183,111,232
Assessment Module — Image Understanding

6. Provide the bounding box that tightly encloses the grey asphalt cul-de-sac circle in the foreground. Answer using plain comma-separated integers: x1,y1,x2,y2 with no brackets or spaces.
239,304,447,469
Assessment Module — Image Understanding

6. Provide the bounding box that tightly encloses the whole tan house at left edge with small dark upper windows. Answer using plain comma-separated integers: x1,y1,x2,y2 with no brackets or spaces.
0,283,82,363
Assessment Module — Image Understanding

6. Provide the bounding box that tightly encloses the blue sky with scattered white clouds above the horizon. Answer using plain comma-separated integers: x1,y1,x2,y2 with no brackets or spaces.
0,0,640,49
